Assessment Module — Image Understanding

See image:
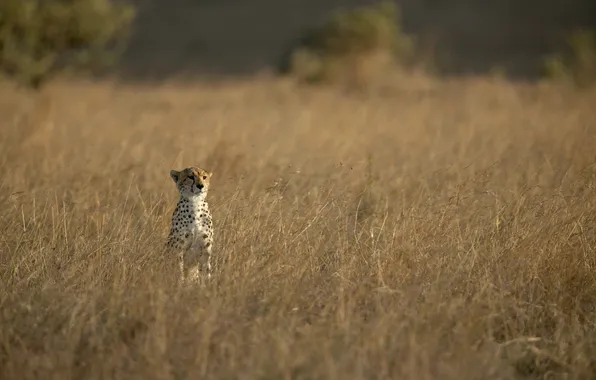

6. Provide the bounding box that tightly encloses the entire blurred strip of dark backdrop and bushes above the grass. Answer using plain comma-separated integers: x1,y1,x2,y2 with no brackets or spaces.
0,0,596,86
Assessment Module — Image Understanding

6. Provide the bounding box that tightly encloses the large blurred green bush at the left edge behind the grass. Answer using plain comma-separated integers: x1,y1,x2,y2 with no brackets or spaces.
0,0,134,87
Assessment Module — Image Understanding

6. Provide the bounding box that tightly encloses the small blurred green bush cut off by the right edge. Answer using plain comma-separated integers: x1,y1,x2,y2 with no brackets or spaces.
545,30,596,87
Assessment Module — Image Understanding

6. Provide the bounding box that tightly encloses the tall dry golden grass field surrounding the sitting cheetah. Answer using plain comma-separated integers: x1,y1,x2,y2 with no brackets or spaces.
0,77,596,380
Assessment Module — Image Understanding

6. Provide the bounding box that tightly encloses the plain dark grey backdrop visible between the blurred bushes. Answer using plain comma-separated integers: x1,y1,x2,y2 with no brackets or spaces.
117,0,596,80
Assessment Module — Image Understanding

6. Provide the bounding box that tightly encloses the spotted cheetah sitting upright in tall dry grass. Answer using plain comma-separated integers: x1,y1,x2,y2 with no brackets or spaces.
166,166,213,282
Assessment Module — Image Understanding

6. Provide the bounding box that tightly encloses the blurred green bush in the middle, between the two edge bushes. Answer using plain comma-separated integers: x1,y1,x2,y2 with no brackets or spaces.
282,1,414,83
